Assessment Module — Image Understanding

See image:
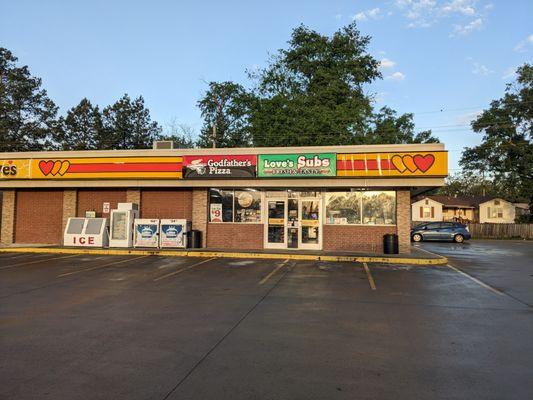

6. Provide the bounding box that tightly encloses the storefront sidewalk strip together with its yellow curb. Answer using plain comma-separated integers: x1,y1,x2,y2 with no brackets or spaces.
0,245,448,265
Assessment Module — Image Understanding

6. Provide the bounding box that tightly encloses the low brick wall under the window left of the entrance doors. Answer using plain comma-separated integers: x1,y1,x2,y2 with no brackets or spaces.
206,223,264,250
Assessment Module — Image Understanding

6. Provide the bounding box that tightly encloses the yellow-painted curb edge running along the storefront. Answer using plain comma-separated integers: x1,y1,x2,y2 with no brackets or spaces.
0,247,448,265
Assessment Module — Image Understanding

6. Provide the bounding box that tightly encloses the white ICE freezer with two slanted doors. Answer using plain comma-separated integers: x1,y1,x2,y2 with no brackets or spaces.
63,218,109,247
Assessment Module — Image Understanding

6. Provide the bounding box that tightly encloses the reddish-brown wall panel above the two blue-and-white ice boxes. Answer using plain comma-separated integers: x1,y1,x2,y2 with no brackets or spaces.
141,189,192,220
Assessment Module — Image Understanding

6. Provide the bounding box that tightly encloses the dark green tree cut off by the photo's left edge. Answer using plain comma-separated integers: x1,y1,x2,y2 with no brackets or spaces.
0,47,60,151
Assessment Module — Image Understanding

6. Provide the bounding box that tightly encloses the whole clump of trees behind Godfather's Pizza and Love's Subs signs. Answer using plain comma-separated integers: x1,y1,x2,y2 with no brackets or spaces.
195,23,437,147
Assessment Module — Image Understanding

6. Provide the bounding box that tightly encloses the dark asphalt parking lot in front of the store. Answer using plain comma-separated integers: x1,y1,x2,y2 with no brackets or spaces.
0,242,533,399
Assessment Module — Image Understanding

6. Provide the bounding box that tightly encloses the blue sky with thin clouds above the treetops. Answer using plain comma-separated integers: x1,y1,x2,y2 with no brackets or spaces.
0,0,533,172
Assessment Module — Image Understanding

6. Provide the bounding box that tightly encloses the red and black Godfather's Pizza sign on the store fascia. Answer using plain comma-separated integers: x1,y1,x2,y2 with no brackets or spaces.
183,154,257,179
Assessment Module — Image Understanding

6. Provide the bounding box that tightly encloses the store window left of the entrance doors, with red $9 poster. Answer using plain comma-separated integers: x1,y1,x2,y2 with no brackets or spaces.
209,189,261,223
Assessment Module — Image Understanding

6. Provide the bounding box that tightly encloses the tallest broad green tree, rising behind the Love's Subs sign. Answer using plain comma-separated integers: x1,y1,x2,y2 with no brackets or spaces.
250,23,381,146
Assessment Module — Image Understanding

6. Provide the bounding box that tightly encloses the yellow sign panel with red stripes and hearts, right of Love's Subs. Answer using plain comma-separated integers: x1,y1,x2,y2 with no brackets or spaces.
337,151,448,177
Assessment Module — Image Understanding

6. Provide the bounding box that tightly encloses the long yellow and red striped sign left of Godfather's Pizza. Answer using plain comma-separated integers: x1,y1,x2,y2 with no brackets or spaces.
0,157,183,179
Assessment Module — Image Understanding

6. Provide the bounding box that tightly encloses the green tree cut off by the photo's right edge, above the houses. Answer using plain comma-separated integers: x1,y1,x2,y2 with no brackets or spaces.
461,64,533,211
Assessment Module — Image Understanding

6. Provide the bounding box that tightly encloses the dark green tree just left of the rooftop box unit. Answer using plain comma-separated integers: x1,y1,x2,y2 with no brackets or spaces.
102,94,161,149
